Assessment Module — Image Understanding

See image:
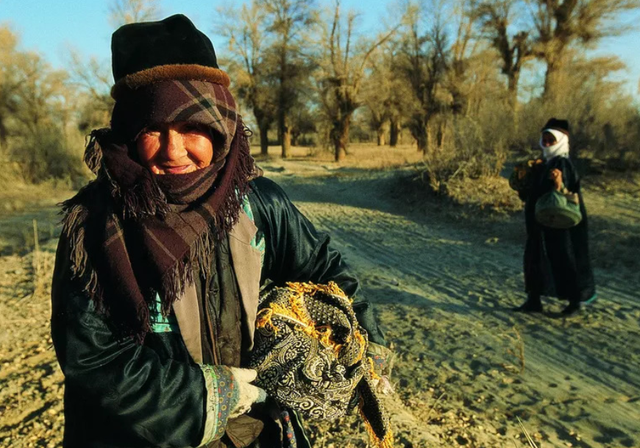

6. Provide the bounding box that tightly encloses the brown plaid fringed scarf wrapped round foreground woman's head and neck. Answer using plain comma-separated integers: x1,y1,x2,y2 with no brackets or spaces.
63,81,259,341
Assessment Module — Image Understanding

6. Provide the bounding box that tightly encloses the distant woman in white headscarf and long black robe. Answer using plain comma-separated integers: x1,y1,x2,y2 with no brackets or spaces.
516,118,596,315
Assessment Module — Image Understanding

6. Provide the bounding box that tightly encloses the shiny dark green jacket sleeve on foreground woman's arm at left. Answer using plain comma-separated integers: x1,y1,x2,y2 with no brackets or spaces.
51,237,206,447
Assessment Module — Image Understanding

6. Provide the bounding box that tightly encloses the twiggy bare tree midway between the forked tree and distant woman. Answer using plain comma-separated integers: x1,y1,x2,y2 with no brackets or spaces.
398,0,479,155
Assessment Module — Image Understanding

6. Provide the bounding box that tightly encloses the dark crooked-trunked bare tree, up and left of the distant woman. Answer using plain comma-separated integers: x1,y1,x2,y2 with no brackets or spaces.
476,0,534,112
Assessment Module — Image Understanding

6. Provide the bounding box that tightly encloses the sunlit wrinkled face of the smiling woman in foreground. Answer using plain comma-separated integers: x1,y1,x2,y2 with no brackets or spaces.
136,122,213,174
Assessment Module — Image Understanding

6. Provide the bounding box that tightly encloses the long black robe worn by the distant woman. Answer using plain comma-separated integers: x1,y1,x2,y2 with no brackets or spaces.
524,157,596,302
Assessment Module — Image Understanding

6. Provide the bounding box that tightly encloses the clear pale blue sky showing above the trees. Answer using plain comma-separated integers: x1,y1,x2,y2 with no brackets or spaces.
0,0,640,98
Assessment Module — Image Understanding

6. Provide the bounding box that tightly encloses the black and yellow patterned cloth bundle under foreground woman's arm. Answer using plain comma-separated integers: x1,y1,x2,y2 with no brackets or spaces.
250,282,393,448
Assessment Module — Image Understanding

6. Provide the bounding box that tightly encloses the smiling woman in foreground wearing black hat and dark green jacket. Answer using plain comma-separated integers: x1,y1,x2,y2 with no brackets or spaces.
51,15,387,448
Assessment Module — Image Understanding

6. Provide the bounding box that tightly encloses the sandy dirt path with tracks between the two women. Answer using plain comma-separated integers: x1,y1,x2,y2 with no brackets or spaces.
267,162,640,447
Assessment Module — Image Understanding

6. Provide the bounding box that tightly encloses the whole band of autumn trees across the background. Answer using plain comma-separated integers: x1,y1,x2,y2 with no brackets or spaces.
0,0,640,189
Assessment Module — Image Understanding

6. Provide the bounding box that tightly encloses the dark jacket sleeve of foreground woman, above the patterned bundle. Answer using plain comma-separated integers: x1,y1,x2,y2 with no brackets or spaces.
249,177,385,345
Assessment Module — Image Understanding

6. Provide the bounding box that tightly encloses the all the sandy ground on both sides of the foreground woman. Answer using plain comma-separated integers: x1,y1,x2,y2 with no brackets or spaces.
0,145,640,448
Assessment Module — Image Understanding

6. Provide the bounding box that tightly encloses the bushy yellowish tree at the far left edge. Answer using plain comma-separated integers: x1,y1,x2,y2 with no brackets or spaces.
0,26,81,182
